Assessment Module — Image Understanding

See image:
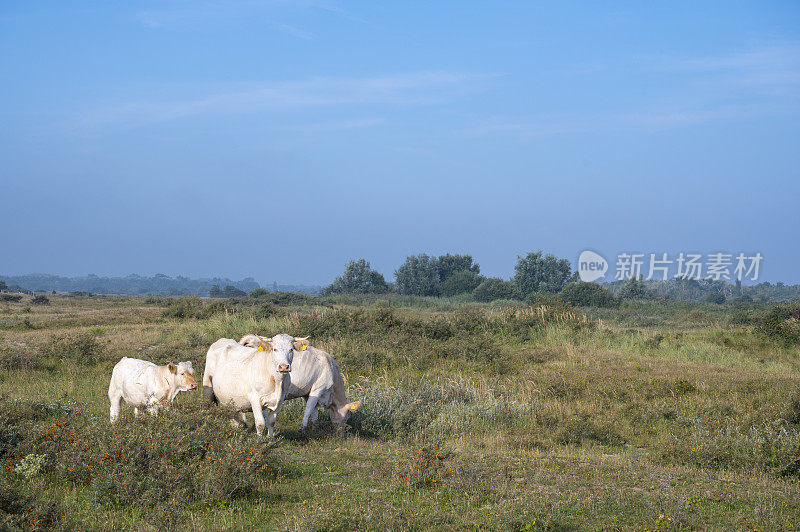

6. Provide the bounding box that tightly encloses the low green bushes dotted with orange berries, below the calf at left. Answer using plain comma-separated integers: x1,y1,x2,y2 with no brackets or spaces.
0,401,274,529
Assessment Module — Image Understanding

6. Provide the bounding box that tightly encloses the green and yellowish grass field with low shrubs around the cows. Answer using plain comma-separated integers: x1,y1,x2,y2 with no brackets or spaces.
0,296,800,530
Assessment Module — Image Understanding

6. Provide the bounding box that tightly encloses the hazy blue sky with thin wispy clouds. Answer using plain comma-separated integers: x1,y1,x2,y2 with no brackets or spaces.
0,0,800,283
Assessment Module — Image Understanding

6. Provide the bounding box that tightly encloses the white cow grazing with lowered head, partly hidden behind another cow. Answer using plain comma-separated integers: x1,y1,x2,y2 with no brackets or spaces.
239,334,361,431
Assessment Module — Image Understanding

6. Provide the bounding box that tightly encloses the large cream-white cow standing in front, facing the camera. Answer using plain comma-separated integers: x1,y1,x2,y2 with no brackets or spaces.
203,334,307,436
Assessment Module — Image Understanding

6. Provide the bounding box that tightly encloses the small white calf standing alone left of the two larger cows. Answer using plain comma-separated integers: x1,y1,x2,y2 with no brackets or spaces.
108,357,197,423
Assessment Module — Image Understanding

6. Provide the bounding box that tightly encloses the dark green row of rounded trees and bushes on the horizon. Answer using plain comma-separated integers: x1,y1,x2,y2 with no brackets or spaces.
322,255,800,307
